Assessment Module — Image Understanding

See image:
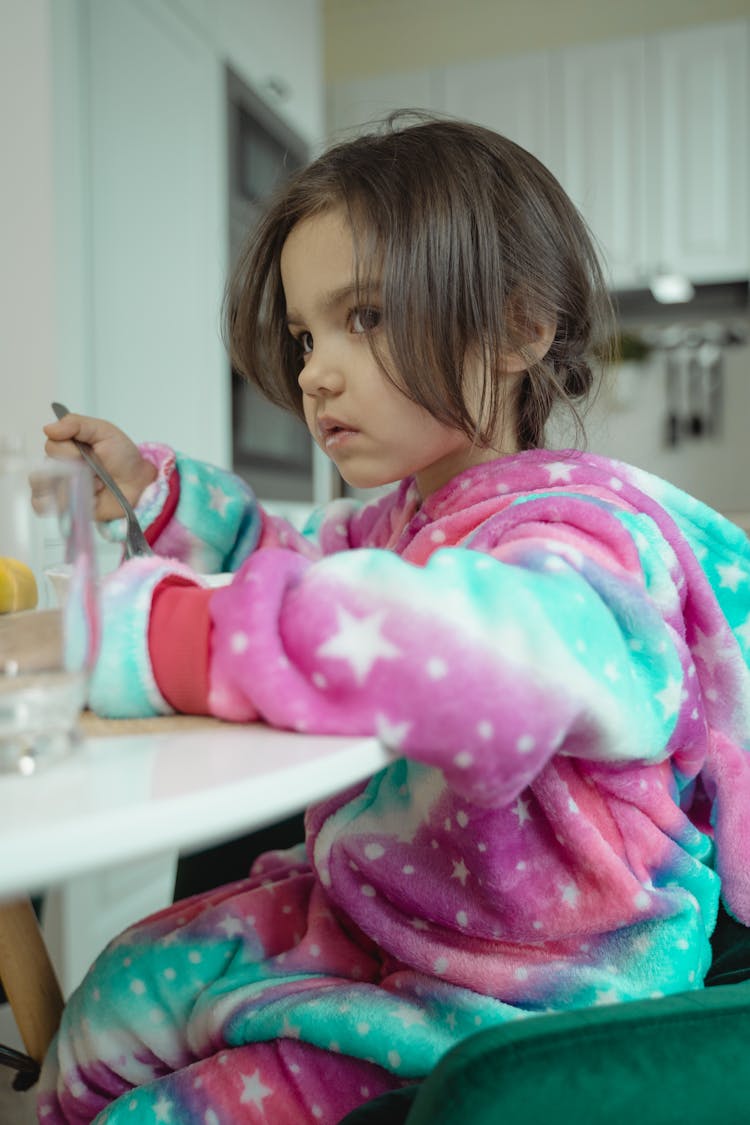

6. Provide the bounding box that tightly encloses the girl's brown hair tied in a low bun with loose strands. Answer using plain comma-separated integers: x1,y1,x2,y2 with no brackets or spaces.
225,114,612,449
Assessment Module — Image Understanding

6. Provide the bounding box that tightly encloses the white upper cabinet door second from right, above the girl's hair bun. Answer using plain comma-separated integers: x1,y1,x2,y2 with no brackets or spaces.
555,39,645,288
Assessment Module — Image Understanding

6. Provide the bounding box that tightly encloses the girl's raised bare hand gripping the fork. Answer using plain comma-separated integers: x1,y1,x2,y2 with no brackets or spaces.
44,414,156,520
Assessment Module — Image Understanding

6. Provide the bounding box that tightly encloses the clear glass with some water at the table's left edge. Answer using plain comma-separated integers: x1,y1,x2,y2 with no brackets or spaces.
0,449,99,774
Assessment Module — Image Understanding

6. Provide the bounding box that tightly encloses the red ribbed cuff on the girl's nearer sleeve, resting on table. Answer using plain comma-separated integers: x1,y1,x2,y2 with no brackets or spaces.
148,578,214,714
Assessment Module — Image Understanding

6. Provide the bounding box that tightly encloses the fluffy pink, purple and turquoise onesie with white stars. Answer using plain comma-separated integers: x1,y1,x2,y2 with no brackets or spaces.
39,446,750,1125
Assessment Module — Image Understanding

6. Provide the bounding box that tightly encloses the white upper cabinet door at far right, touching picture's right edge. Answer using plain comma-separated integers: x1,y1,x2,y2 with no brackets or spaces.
649,21,750,281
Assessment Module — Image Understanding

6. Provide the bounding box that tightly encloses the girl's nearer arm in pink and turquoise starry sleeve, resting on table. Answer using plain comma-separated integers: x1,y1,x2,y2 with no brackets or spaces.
92,497,703,804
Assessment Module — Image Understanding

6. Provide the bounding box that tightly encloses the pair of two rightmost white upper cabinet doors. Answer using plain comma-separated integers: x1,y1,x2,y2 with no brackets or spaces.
558,21,750,288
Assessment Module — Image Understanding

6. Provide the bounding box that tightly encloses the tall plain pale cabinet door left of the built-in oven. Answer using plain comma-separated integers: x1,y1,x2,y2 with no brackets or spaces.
87,0,229,465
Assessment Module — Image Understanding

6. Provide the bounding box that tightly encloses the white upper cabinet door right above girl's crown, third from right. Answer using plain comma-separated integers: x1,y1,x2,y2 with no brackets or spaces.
444,52,555,171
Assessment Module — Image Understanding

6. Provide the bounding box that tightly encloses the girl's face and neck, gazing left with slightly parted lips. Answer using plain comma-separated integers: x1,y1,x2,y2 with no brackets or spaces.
281,209,508,497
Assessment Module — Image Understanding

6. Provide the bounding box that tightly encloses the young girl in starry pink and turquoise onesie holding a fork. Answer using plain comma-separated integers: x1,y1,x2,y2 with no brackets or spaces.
39,122,750,1125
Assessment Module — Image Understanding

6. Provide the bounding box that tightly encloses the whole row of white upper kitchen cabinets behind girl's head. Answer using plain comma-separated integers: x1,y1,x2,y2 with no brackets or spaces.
329,20,750,289
